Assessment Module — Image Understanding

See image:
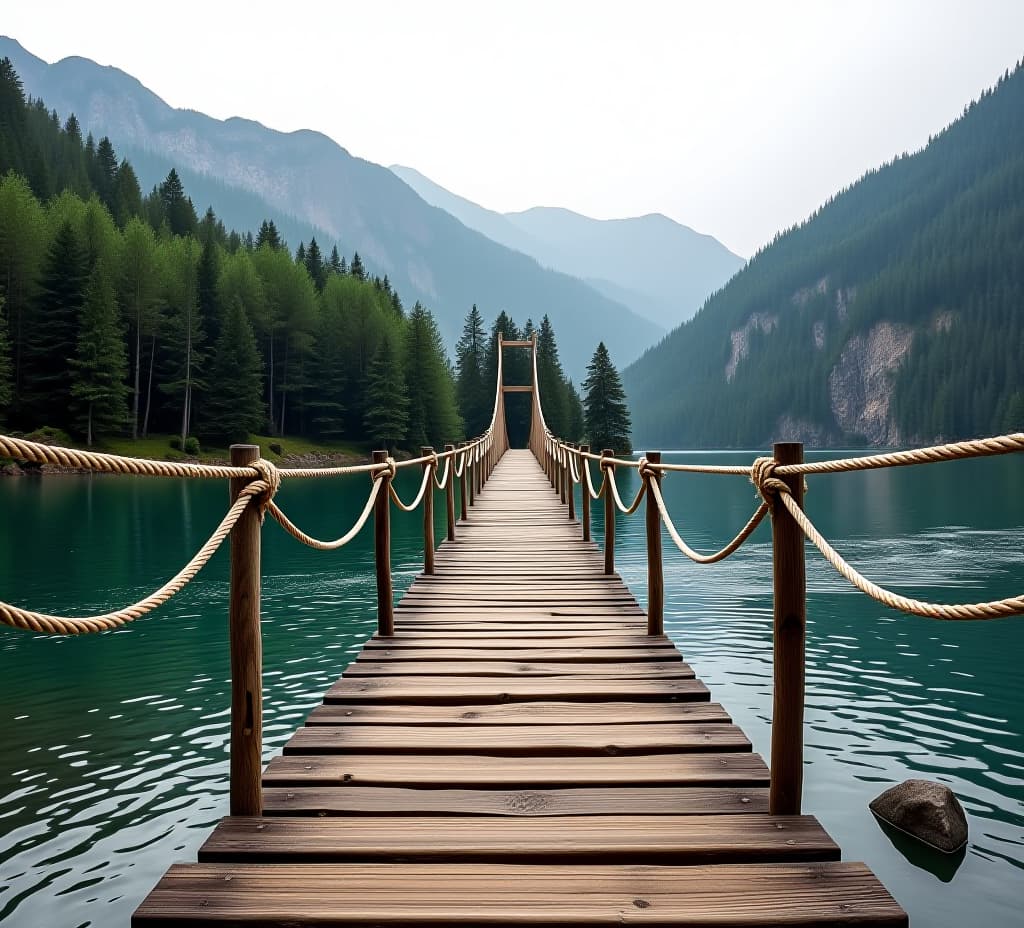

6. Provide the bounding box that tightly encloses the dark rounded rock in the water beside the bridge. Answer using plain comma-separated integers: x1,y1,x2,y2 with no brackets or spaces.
868,779,967,854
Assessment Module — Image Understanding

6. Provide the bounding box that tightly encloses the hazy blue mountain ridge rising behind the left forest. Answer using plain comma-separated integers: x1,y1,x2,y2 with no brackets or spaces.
0,38,665,380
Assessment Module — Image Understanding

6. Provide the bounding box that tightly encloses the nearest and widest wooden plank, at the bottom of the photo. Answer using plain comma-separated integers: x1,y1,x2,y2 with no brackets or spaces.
132,862,907,928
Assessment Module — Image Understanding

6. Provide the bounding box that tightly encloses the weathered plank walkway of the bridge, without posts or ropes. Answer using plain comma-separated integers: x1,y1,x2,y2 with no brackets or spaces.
132,451,906,926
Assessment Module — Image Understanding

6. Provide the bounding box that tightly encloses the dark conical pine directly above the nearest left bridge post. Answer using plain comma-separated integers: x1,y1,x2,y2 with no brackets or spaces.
201,297,264,442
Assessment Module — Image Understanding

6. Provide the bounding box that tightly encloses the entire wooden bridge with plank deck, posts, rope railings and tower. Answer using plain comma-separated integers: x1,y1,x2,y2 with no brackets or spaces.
9,340,1024,928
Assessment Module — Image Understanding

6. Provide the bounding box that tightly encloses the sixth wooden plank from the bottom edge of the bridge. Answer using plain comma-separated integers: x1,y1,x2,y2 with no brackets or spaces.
306,702,730,726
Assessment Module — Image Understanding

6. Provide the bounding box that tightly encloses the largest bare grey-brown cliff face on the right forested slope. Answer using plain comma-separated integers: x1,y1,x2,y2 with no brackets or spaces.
828,322,913,445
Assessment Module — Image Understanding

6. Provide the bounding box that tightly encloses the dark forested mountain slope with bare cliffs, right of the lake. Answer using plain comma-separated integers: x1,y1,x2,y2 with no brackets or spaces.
624,58,1024,448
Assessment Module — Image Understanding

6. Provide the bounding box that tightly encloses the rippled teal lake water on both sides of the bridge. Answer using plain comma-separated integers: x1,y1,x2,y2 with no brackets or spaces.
0,453,1024,928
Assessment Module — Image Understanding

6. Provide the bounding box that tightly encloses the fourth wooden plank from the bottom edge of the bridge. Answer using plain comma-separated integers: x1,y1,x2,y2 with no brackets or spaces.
263,753,768,789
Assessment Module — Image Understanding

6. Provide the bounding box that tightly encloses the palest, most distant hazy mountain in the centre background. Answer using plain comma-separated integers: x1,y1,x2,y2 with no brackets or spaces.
391,165,743,328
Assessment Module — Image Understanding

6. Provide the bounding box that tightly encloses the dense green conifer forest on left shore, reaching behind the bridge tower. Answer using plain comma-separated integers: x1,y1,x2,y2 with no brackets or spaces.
0,59,582,450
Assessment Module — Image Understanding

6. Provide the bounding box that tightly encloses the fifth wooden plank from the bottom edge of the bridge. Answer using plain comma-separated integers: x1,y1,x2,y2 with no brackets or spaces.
284,723,751,757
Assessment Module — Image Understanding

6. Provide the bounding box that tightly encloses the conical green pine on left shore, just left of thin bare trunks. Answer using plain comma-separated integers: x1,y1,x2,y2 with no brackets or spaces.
71,264,128,447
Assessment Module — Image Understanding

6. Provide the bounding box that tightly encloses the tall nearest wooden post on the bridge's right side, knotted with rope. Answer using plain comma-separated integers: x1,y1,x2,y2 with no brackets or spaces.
768,441,807,815
